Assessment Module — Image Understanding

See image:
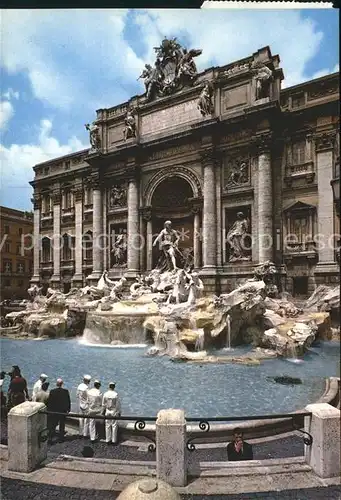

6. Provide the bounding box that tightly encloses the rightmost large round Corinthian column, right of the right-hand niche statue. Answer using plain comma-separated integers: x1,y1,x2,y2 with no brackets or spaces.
256,135,273,262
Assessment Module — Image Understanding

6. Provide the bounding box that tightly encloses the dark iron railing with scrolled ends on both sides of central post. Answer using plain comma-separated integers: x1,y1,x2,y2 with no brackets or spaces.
40,410,313,452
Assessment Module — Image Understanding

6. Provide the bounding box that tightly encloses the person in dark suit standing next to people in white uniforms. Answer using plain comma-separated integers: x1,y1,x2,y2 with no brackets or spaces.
47,378,71,444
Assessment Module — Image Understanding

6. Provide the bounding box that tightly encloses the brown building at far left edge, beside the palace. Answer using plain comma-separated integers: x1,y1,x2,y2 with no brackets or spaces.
0,207,33,300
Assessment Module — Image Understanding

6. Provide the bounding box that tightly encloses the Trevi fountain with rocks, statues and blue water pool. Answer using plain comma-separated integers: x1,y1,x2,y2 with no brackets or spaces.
1,221,340,416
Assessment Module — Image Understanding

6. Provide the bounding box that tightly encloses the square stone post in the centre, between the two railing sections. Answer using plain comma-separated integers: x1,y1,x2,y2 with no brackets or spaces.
156,409,187,486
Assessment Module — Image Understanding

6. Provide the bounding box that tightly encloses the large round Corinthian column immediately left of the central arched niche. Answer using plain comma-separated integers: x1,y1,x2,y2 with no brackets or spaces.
127,173,141,274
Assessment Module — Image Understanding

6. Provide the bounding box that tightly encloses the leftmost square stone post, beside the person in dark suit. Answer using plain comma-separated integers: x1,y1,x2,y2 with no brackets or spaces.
8,401,47,472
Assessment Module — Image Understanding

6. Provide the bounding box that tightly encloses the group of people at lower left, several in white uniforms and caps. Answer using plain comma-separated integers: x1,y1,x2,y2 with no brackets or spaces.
0,365,121,444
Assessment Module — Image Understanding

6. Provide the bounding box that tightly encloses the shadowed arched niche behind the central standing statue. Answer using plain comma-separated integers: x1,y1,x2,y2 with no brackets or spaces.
151,175,194,265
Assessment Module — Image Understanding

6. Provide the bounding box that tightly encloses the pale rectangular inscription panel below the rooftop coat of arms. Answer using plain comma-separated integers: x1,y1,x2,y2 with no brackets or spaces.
141,99,202,135
